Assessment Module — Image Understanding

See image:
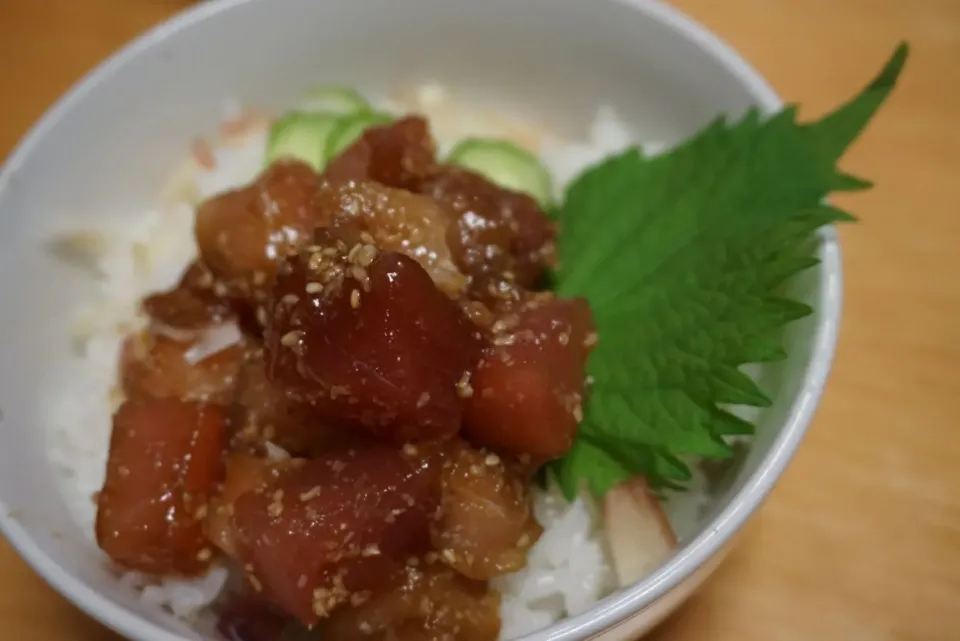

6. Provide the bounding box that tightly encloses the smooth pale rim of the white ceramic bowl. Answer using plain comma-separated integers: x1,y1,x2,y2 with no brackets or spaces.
0,0,843,641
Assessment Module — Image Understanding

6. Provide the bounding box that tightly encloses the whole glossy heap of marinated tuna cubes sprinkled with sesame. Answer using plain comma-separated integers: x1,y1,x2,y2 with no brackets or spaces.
97,117,596,641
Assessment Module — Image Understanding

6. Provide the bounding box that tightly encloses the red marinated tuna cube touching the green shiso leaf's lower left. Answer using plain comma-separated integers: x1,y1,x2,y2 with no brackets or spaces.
464,294,596,462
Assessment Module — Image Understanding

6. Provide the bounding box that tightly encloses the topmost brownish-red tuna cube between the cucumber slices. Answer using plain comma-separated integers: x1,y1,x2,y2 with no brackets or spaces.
323,116,436,190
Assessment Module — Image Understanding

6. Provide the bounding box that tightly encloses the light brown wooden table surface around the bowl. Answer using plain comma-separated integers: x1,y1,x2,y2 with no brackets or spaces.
0,0,960,641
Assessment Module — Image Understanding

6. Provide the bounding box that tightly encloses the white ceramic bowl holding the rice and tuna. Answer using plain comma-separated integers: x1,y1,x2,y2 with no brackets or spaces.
0,0,841,641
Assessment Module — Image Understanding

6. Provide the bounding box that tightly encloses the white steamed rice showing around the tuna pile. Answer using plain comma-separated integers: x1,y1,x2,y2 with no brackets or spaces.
41,87,696,639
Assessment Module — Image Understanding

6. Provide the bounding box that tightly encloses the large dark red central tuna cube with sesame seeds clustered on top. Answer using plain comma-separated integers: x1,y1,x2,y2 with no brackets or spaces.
266,228,482,442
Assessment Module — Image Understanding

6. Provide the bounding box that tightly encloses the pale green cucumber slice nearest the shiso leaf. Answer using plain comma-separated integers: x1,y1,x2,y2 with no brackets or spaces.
448,138,553,208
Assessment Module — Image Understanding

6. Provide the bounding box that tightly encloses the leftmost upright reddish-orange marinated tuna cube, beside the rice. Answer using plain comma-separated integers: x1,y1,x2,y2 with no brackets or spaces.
96,399,225,575
